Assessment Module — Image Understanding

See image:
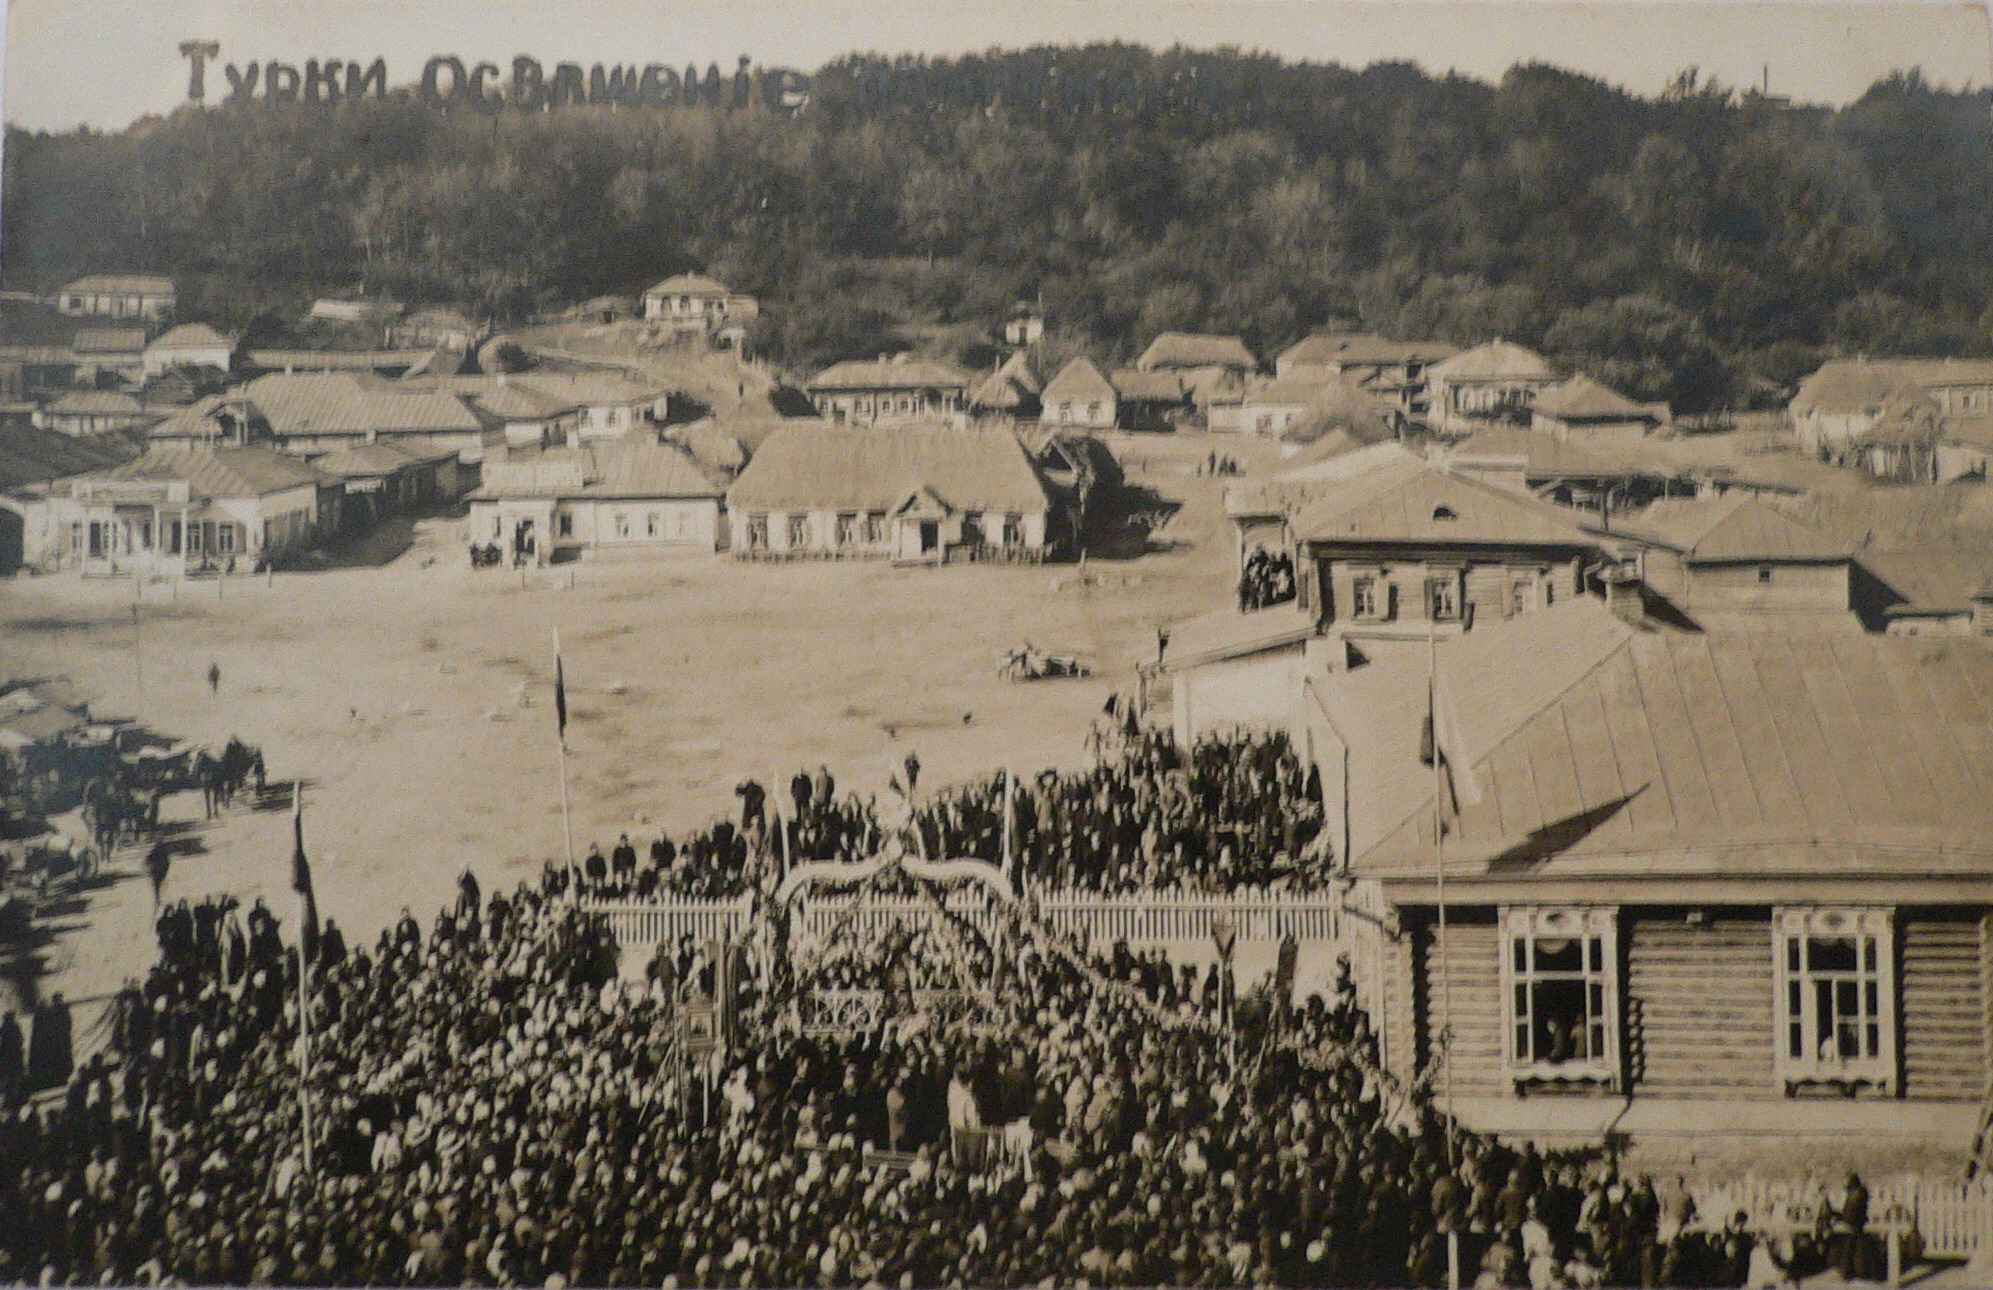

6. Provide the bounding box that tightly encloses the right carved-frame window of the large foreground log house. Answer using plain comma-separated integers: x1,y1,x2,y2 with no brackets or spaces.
1776,909,1895,1085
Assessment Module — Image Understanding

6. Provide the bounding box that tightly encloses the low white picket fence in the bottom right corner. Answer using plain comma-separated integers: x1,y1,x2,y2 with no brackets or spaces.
1690,1174,1993,1258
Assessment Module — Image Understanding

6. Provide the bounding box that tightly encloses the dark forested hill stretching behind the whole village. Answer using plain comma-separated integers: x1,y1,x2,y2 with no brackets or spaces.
4,46,1993,409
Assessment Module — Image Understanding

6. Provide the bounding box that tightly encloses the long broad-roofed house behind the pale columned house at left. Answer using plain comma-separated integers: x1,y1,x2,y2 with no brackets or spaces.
231,373,498,463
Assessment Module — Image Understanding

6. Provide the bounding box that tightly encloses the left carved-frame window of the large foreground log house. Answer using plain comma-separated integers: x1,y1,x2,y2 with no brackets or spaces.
1503,909,1618,1081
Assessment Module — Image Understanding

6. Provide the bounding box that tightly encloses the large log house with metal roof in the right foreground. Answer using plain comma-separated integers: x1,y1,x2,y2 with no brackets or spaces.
1289,600,1993,1162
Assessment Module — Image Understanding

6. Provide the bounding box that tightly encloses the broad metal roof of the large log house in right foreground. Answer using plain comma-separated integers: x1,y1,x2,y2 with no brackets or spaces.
1311,598,1993,881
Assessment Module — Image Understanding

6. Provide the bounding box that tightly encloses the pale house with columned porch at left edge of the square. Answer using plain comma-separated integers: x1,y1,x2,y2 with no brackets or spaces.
0,447,343,576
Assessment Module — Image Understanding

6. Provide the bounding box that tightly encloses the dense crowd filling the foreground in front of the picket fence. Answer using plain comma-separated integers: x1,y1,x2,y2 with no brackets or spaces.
0,821,1865,1288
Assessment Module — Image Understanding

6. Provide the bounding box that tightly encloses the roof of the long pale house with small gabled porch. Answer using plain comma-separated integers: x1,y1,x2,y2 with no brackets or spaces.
727,423,1050,512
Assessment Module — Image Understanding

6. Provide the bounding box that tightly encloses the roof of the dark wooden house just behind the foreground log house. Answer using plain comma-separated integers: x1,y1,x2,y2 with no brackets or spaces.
1291,459,1600,548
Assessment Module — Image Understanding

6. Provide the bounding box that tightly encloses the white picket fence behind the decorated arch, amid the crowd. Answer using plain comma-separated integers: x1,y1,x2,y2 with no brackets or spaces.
582,891,1343,947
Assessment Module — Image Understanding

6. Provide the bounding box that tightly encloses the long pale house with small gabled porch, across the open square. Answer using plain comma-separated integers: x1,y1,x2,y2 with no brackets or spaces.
727,425,1052,564
